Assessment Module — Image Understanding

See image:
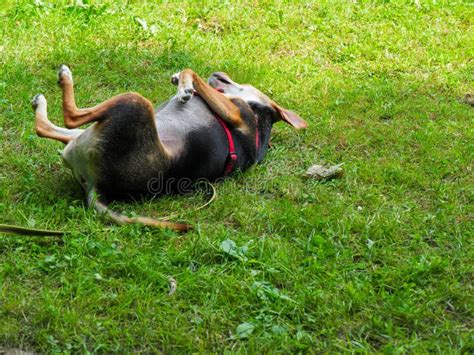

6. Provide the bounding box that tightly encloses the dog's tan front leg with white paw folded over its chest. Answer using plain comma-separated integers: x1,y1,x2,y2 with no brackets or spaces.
171,69,247,130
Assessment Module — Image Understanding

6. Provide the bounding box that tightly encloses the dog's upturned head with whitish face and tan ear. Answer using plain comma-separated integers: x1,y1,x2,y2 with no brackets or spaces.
208,72,308,129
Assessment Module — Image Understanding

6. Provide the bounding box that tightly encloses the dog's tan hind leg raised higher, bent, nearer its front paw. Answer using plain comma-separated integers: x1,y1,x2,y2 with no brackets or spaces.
58,64,153,128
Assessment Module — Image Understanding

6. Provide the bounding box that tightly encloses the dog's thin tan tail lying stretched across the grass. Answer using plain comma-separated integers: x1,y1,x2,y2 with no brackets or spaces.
87,189,192,232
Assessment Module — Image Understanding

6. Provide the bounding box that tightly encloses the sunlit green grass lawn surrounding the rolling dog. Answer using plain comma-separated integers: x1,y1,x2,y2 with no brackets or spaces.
0,0,474,353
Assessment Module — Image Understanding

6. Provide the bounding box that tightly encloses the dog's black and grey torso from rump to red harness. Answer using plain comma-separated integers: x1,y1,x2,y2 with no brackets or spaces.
62,97,228,200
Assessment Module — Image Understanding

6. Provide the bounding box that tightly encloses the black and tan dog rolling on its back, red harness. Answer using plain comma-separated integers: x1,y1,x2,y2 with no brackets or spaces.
32,65,306,231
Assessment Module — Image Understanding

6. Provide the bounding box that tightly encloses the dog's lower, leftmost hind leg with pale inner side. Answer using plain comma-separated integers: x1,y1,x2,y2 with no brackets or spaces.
31,94,83,144
